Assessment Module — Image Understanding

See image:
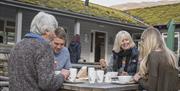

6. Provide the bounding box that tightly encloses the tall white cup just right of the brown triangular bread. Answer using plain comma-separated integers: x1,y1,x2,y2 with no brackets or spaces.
88,67,96,83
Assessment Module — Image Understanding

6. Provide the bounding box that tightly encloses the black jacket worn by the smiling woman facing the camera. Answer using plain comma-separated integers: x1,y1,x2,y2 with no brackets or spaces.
108,47,139,75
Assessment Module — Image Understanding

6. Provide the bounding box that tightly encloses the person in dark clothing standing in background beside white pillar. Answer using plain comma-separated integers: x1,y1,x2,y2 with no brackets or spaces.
68,34,81,63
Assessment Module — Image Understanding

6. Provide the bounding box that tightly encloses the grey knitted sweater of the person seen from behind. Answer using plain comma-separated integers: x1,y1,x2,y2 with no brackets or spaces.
8,38,64,91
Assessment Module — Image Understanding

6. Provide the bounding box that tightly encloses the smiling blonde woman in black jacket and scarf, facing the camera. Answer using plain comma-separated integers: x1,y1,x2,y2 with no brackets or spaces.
107,31,138,75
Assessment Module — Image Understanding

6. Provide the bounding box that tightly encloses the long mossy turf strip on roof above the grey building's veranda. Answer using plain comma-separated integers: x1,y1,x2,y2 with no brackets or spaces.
18,0,143,24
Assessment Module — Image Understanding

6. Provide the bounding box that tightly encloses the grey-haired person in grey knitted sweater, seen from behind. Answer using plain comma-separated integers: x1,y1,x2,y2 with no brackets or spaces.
8,12,69,91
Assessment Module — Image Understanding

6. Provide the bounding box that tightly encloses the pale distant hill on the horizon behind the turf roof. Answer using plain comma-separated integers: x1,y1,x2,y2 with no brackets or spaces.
111,0,180,10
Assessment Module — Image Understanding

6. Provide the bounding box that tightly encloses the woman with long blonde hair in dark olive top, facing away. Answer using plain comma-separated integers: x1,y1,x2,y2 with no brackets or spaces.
134,27,178,91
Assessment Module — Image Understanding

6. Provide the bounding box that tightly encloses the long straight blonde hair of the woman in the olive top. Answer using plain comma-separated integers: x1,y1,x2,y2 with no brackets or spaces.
139,27,178,77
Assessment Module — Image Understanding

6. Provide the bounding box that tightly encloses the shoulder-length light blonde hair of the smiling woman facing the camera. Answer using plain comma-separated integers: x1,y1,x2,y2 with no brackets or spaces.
112,31,135,53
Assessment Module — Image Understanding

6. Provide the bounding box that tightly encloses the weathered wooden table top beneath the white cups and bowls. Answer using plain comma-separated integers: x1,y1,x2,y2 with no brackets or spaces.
60,82,138,91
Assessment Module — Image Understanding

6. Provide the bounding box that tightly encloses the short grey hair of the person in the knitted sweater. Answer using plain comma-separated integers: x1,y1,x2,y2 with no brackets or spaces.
30,12,58,35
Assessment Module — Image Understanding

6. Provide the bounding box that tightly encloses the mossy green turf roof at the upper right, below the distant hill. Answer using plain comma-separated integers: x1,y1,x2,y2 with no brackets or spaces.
127,3,180,25
